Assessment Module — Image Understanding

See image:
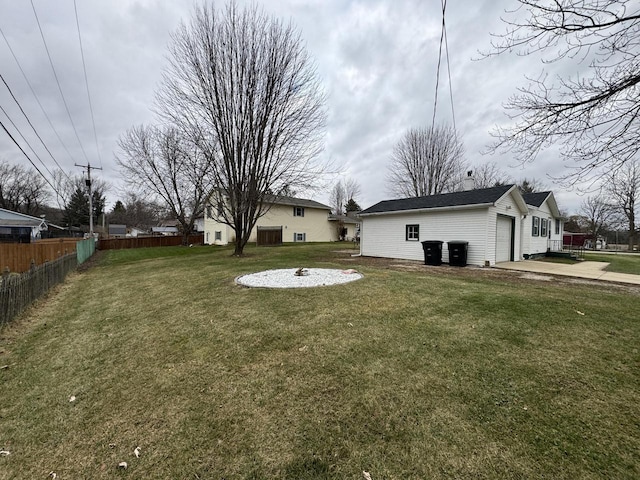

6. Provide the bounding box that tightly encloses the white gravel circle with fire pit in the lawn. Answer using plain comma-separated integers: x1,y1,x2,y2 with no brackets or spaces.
236,268,364,288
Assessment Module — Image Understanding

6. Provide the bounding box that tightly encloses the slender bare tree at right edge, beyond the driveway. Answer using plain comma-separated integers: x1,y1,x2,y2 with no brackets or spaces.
606,160,640,251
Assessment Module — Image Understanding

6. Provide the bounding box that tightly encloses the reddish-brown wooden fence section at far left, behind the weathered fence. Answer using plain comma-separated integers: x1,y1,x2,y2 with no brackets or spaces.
0,238,78,273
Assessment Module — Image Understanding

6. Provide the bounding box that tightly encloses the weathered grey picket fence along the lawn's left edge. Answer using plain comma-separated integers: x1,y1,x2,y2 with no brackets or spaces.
0,252,78,327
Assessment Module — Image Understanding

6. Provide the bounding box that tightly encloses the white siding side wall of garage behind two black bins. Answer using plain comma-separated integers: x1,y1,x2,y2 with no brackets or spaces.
360,208,495,265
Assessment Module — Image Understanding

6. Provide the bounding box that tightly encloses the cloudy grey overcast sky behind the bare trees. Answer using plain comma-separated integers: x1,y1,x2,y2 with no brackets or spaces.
0,0,596,213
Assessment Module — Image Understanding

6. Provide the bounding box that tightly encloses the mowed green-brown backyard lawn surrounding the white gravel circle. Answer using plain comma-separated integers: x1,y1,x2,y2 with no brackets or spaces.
0,244,640,480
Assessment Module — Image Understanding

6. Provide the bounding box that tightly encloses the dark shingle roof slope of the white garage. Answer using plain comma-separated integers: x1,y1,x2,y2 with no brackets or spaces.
360,185,514,215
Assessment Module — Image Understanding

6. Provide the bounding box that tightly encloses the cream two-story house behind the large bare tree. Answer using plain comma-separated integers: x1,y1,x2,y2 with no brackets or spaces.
204,196,338,245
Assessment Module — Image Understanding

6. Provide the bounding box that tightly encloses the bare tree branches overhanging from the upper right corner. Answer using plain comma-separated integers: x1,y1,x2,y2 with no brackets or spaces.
489,0,640,184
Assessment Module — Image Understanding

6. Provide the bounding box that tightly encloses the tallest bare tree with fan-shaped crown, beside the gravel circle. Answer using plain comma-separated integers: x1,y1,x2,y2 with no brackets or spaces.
156,3,326,255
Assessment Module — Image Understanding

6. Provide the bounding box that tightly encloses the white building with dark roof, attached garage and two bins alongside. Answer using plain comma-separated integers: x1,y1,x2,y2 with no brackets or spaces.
360,185,562,266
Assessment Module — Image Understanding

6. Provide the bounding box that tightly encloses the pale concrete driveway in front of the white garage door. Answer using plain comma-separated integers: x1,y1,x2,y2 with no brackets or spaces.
495,260,640,285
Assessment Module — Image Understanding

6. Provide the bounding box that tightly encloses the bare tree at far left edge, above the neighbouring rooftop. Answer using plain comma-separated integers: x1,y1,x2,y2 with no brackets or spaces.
0,161,51,215
